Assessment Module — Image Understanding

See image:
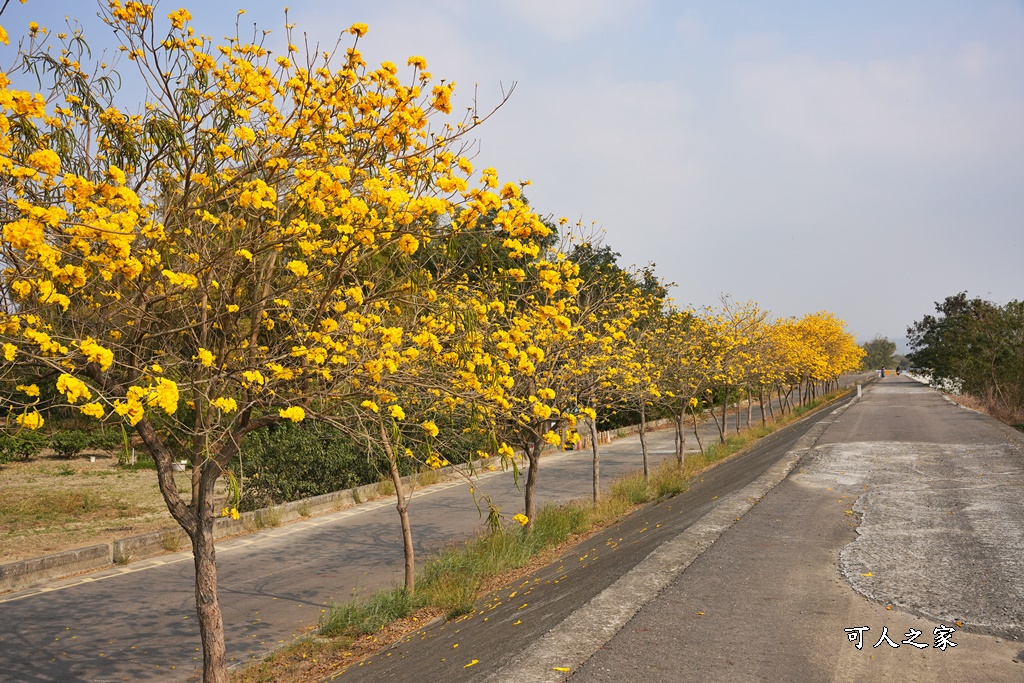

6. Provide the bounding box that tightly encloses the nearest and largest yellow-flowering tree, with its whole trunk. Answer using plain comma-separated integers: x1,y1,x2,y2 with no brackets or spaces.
0,7,563,683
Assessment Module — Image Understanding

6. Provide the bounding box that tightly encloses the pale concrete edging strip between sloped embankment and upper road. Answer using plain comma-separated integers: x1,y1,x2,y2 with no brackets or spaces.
486,396,857,683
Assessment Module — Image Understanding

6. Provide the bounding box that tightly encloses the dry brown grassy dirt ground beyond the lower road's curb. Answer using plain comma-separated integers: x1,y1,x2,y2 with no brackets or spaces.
0,451,226,563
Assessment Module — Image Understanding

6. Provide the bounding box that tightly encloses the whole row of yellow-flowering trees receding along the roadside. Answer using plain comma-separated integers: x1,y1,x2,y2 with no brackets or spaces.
0,0,859,682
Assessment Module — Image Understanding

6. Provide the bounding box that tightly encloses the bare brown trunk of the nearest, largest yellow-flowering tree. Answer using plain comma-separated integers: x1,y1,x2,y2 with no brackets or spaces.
185,460,228,683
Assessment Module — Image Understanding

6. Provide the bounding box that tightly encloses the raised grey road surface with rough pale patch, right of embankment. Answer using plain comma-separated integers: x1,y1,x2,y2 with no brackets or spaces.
571,377,1024,683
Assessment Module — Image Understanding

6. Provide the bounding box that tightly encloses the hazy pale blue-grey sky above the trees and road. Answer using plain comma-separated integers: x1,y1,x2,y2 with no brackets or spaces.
0,0,1024,341
